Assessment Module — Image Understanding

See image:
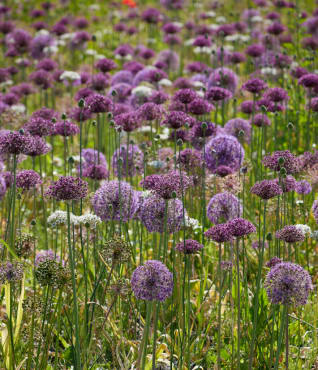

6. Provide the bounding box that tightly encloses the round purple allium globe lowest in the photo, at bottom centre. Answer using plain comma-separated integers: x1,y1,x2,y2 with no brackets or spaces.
131,260,173,302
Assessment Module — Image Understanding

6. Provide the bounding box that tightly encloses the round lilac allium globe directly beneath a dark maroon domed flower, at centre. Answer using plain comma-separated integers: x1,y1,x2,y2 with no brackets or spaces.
138,194,183,233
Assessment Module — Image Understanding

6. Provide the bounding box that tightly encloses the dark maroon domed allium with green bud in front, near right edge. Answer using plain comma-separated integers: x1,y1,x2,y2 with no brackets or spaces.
262,150,300,174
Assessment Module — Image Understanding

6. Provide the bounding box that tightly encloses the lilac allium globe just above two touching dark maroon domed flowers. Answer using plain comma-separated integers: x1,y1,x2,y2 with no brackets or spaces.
207,192,243,224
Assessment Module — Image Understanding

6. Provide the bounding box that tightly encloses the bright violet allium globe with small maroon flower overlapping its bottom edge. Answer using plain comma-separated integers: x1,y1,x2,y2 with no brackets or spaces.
204,135,244,172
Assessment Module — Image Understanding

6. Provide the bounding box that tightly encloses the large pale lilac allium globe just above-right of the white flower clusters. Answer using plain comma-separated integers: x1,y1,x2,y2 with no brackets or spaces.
92,180,139,222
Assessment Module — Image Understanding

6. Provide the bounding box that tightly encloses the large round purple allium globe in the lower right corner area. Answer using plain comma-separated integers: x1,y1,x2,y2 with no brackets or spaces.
264,262,313,306
